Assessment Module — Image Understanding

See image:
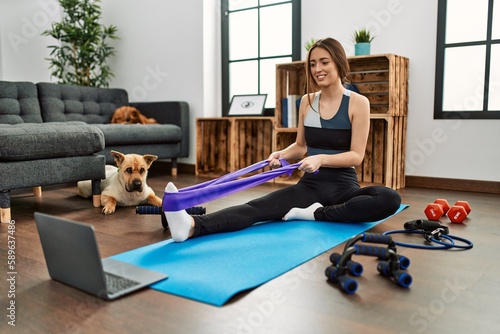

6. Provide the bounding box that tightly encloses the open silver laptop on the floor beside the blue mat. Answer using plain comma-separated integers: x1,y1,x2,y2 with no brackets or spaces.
35,212,168,300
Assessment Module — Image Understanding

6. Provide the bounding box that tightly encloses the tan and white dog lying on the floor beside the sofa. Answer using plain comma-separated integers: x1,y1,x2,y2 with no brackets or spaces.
78,151,162,215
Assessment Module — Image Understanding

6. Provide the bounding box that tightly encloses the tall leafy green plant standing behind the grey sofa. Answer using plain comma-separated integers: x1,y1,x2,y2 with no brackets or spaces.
42,0,118,87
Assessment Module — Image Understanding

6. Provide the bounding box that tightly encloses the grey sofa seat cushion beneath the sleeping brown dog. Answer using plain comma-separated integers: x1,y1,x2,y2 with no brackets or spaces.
95,124,182,147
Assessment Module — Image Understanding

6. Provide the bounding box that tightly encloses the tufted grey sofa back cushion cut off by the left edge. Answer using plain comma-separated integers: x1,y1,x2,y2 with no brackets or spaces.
0,81,42,124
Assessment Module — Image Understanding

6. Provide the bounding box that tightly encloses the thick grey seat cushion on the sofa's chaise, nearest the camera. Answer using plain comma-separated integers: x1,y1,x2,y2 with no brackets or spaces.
0,122,104,161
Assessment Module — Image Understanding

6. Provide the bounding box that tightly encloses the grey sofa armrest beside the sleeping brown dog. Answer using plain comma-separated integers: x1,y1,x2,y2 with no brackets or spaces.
130,101,189,158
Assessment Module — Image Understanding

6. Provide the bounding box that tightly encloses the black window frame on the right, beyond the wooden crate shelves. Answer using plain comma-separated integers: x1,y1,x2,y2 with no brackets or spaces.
434,0,500,119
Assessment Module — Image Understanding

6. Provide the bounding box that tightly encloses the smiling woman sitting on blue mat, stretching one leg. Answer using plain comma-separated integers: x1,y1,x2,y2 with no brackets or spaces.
165,38,401,242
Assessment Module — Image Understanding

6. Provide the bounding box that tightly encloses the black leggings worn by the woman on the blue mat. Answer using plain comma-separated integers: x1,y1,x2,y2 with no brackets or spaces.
194,168,401,237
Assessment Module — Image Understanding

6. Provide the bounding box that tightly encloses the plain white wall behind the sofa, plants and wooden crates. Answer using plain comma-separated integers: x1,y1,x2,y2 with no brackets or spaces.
0,0,500,181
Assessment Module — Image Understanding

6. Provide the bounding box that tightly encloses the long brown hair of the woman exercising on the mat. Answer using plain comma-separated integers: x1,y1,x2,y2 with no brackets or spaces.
306,37,349,105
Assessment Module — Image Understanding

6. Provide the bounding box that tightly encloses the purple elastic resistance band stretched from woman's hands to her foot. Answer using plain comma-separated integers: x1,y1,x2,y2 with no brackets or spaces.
162,159,306,211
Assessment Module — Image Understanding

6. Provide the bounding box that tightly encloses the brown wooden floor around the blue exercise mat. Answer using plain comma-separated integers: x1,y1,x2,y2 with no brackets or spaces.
0,165,500,334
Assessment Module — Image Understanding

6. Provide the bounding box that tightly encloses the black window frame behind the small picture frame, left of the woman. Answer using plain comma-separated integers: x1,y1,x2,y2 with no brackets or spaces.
221,0,302,116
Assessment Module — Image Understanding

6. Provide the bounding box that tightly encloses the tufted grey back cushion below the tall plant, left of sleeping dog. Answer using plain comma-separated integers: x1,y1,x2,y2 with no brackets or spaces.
36,82,128,124
